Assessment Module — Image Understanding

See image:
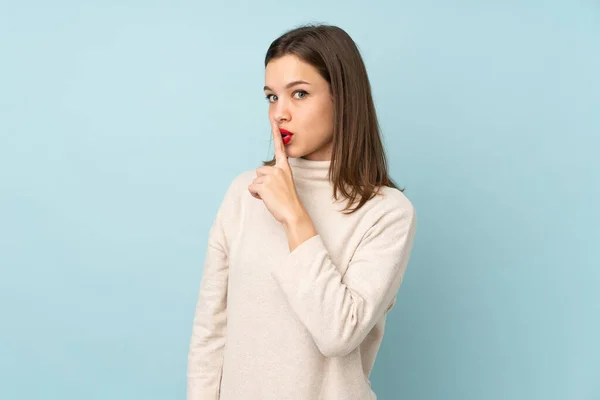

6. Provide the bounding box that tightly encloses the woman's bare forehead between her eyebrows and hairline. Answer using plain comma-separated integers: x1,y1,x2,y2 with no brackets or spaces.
265,54,326,88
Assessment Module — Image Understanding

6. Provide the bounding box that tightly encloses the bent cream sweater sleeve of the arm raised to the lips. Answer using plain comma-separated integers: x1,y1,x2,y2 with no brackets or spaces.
271,207,416,357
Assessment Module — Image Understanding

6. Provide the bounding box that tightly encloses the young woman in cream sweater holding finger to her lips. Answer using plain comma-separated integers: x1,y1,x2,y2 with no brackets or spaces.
187,25,416,400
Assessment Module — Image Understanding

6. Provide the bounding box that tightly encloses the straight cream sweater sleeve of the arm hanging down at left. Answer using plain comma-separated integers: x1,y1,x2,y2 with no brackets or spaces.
187,180,236,400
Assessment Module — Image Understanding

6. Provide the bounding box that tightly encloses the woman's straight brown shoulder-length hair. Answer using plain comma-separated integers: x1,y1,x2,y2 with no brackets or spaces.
262,24,404,214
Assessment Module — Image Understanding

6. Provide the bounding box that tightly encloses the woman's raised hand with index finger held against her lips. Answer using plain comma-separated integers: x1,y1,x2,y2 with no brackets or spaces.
248,120,304,223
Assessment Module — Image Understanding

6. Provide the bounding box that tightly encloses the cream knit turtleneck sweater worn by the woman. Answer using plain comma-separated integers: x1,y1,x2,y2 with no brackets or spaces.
187,158,416,400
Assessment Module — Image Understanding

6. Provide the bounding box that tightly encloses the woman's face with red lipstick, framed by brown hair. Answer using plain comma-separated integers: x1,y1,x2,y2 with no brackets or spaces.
265,55,333,161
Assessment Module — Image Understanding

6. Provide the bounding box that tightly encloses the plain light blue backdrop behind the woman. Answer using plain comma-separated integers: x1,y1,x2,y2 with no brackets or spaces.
0,0,600,400
